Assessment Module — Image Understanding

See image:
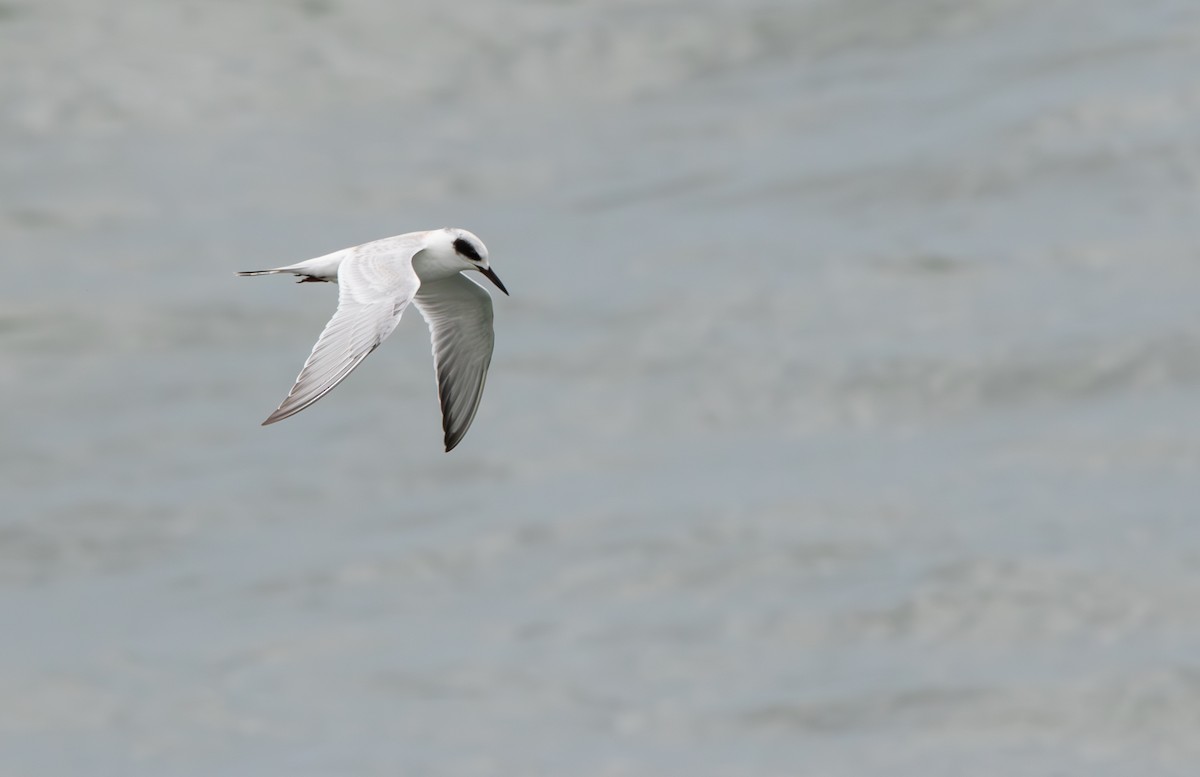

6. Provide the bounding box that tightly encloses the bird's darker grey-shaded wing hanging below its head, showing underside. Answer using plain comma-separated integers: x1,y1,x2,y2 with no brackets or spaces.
414,273,496,452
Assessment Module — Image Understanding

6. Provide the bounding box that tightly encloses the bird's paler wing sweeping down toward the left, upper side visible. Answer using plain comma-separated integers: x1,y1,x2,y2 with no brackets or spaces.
263,241,424,426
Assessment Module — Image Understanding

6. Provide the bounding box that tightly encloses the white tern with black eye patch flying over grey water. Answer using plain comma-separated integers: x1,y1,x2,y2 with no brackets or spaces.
238,228,509,453
